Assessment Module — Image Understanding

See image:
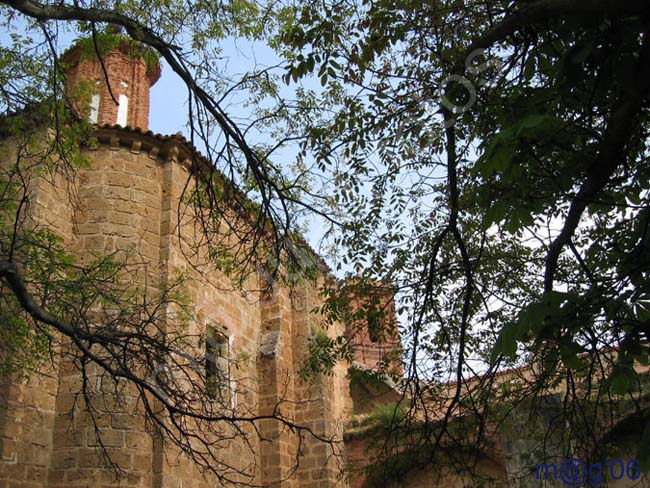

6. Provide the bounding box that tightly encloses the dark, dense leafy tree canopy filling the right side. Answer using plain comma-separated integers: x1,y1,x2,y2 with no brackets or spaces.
274,1,650,478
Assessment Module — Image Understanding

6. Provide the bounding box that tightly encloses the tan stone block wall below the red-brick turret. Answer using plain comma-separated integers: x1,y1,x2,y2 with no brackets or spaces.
0,128,349,488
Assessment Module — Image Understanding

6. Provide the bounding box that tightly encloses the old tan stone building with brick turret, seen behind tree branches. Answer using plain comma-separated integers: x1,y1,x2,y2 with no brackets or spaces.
0,37,648,488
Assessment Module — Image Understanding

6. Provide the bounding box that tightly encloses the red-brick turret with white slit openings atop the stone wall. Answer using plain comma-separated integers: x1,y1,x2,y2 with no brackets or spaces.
61,33,160,131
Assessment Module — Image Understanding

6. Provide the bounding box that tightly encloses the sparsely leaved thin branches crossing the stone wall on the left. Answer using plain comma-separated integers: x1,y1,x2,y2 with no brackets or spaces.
0,0,333,486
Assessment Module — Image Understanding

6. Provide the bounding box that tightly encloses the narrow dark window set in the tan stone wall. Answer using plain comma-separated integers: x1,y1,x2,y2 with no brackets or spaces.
205,325,230,403
